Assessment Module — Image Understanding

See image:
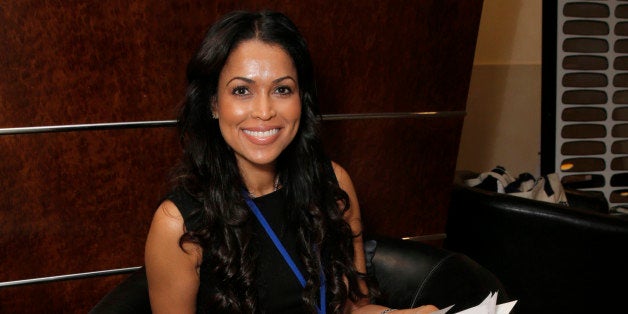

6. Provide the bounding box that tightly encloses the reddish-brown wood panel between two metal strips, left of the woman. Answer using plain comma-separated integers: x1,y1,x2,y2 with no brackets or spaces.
0,129,179,281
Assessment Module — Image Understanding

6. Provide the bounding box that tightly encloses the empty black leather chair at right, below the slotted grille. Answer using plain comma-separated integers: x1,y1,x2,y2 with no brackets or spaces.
444,172,628,313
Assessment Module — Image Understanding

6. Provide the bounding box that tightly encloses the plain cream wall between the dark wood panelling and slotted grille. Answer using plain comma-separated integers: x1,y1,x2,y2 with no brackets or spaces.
456,0,542,176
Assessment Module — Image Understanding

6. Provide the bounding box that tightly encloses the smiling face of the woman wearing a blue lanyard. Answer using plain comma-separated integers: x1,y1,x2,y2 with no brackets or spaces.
213,40,301,174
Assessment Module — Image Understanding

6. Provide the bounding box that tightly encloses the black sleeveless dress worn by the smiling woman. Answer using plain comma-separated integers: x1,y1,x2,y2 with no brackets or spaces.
167,189,307,313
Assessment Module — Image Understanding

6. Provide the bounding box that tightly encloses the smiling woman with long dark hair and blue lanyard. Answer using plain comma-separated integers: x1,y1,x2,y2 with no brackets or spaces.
145,12,435,313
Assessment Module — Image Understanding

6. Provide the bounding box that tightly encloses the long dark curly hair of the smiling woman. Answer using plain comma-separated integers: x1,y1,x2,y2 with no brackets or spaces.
175,11,365,313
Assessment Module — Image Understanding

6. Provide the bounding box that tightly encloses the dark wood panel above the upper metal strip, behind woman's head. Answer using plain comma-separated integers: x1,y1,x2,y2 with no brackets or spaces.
0,0,481,127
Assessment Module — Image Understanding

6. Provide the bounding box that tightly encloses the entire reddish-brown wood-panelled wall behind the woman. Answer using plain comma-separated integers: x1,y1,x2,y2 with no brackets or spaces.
0,0,482,313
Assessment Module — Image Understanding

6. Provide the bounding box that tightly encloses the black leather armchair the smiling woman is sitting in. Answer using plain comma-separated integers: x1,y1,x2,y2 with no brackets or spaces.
90,238,509,314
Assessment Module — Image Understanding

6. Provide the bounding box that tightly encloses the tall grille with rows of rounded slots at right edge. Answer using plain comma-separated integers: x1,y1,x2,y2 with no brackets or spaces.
541,0,628,207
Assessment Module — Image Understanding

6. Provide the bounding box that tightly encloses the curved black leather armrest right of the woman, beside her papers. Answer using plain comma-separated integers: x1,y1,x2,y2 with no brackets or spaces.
365,238,508,311
